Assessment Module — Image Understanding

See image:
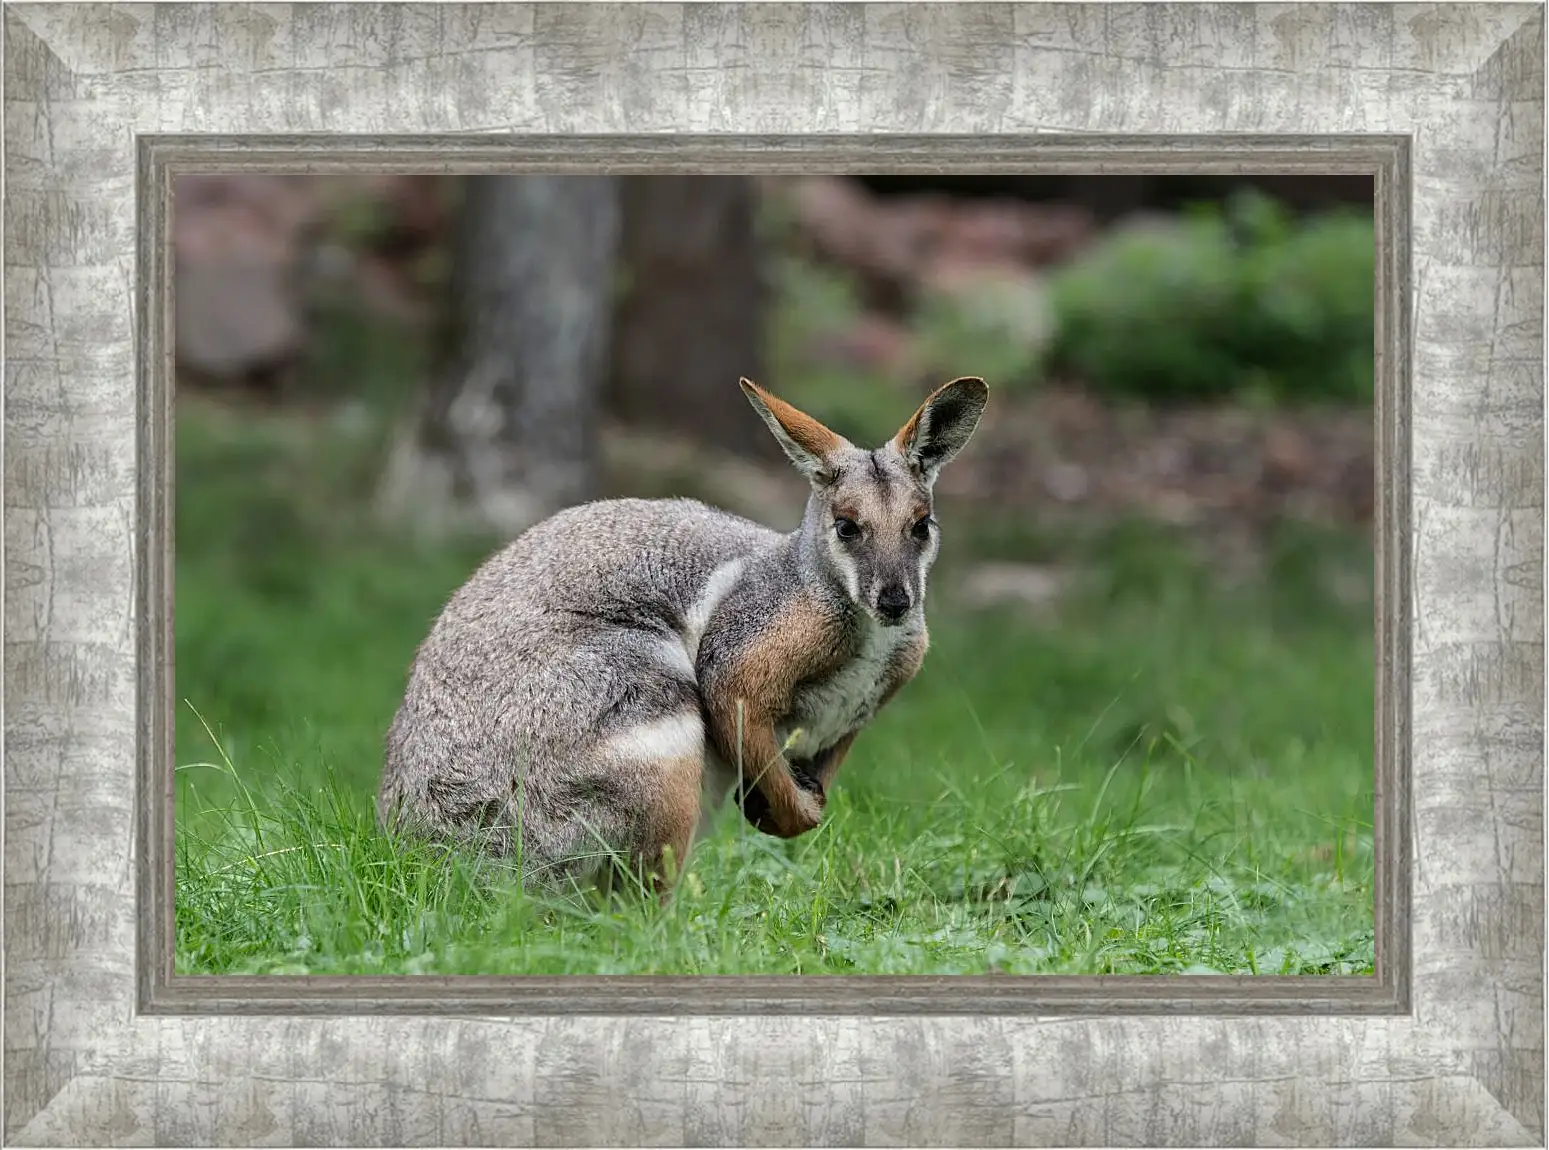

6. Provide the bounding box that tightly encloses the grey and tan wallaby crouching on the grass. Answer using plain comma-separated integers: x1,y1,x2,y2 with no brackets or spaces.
378,378,988,896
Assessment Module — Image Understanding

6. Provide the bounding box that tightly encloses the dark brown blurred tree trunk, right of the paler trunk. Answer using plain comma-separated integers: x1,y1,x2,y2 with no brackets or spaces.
609,175,771,456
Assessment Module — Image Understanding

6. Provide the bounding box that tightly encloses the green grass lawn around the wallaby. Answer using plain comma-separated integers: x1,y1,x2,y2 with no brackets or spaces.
177,393,1372,973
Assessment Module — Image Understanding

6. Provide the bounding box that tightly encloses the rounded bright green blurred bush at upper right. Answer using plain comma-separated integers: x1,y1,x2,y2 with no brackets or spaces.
1050,195,1376,401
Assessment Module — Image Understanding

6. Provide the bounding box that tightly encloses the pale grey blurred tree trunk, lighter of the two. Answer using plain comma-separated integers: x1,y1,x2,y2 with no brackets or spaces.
381,175,619,536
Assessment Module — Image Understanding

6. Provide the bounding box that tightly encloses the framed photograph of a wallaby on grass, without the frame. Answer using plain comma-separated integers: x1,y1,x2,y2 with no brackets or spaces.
169,172,1376,976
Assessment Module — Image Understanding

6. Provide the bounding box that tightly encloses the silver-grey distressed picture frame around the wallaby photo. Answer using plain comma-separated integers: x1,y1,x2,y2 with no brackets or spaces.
3,3,1544,1145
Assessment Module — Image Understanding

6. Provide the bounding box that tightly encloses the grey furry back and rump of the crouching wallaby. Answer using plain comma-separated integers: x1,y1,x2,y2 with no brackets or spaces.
378,499,795,876
